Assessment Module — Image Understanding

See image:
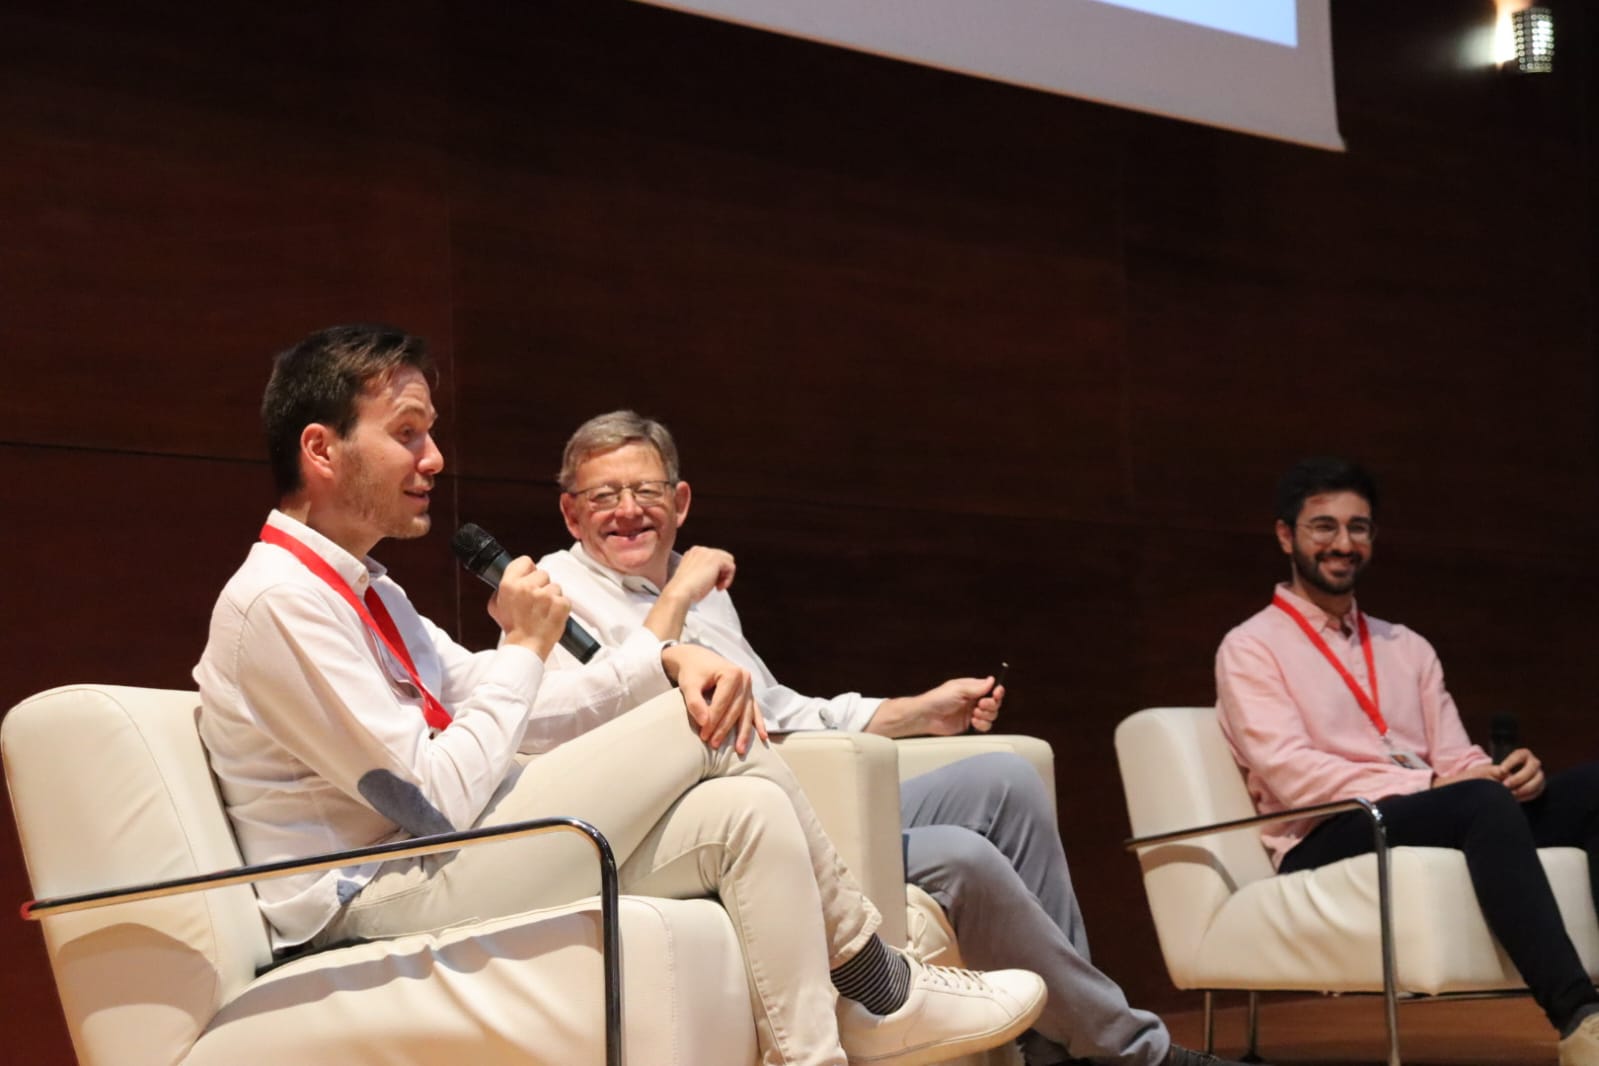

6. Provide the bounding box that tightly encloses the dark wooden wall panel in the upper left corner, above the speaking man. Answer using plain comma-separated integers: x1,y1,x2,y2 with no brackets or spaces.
0,5,449,459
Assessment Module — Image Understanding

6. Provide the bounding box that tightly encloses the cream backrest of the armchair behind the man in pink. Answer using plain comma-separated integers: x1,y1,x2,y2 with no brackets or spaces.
1116,706,1274,988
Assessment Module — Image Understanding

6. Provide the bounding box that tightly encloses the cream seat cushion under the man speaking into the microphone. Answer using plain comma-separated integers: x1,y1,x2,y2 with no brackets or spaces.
182,897,756,1066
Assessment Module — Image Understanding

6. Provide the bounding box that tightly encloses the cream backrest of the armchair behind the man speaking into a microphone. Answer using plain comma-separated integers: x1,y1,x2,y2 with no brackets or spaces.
0,686,270,1066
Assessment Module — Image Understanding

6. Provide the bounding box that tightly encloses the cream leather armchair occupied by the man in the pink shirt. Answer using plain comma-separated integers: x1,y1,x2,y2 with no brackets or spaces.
1116,706,1599,1066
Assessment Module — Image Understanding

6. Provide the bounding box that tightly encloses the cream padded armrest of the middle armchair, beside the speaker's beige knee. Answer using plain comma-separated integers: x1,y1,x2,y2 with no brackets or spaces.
772,730,905,946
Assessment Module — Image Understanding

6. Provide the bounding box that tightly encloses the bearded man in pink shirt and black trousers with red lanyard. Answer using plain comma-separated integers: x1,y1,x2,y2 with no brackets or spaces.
1215,459,1599,1066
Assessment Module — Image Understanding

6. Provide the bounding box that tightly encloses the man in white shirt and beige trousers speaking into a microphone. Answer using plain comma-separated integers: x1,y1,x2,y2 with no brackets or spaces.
195,326,1043,1066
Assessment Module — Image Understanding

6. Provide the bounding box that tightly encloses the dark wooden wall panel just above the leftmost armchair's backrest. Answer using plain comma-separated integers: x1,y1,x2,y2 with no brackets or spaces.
0,446,260,706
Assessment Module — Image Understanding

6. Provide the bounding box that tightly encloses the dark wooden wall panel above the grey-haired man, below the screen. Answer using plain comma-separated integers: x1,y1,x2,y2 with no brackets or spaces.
456,6,1119,521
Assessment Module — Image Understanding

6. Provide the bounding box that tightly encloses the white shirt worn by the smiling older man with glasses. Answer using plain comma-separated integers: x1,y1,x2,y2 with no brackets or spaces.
539,543,883,732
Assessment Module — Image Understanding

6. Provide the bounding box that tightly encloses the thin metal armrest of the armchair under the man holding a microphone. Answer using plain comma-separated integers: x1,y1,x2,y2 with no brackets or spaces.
22,818,622,1066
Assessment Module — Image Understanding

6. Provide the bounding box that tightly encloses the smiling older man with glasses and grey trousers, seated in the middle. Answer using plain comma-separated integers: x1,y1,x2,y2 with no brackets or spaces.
536,411,1260,1066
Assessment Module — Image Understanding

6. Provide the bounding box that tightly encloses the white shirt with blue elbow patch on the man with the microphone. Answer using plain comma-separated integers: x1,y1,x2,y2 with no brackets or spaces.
193,511,544,948
